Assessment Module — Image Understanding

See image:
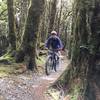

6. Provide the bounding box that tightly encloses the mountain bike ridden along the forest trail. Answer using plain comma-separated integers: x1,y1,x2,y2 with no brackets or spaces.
45,50,59,75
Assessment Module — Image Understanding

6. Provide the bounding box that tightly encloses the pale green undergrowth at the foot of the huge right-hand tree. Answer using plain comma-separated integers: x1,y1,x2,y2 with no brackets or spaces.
47,79,83,100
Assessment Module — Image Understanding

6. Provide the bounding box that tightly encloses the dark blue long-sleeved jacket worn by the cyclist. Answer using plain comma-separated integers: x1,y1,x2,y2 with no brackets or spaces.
45,35,63,49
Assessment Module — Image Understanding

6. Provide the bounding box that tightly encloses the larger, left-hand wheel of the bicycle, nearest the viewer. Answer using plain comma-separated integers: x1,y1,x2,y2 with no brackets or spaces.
45,57,52,75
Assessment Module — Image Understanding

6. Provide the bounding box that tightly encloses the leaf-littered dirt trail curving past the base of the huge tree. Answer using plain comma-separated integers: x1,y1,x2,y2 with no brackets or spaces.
0,52,69,100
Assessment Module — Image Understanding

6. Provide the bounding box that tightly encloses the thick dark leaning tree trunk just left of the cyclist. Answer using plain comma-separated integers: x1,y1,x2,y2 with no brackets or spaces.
17,0,44,70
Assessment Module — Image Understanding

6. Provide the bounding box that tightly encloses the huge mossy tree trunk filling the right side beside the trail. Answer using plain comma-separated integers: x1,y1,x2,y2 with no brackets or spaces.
53,0,100,100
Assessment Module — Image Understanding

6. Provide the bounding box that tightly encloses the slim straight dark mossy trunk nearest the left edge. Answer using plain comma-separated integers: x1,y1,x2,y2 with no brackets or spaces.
7,0,16,51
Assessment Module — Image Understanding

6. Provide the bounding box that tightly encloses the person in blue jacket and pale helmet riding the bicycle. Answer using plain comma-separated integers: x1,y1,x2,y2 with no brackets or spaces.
45,31,63,69
